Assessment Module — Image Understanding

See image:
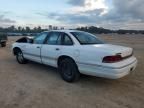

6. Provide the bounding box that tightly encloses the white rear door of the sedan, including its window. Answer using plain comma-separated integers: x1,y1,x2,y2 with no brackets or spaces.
41,32,62,67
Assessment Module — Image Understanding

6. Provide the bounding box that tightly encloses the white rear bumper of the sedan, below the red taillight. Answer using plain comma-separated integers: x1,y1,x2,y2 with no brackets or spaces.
78,58,137,79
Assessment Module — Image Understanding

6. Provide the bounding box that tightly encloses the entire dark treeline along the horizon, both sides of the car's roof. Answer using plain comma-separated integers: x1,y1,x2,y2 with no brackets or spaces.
0,25,144,34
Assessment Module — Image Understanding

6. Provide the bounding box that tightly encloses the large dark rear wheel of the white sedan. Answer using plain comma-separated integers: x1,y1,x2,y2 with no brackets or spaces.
59,58,80,82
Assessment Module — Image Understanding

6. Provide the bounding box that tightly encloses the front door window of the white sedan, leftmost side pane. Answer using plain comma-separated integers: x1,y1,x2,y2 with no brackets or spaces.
34,33,48,44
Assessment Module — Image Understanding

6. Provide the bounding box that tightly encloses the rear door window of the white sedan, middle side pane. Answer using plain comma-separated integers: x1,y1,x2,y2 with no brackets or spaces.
47,32,61,45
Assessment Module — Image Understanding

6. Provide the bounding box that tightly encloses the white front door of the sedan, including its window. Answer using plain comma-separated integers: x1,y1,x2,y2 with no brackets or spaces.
24,32,48,63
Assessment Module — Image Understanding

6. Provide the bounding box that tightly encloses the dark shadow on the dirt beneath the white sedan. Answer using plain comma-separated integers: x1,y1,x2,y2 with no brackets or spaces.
26,61,124,86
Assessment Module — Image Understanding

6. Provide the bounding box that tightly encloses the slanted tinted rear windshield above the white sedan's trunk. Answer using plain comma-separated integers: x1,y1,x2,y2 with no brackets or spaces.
71,32,104,45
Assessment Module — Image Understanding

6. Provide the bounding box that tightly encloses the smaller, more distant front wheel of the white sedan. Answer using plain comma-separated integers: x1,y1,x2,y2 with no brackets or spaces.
16,50,28,64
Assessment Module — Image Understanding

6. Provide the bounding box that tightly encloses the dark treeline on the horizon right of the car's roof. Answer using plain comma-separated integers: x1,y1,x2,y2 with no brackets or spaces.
77,26,144,34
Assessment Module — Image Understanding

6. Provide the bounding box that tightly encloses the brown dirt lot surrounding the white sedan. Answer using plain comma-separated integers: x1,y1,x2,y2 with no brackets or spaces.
0,35,144,108
